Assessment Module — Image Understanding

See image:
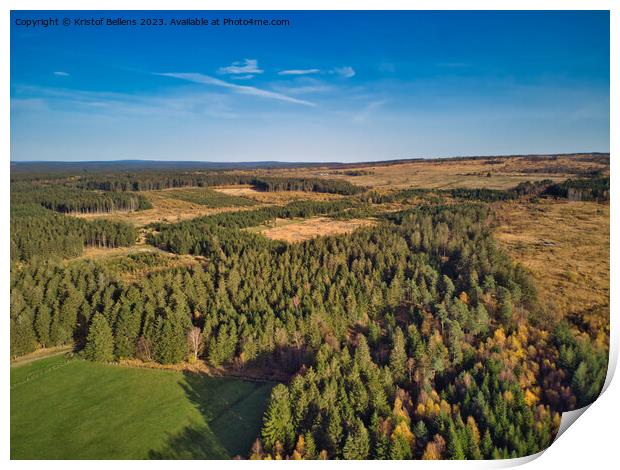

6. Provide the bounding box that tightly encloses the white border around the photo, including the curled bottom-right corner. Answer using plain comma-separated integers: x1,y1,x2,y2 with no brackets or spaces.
0,0,620,470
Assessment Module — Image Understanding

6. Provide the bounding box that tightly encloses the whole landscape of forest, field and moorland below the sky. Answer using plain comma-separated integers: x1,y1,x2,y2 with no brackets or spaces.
10,154,610,459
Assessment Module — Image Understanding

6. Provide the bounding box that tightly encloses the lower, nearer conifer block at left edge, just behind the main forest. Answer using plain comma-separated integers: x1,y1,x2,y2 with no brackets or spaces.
10,204,137,262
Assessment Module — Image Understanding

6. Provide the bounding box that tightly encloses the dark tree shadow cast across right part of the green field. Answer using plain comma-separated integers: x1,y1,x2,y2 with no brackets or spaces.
148,372,275,460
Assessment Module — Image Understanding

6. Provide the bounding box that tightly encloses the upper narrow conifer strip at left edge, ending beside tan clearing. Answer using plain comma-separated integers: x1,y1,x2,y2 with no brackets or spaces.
11,183,152,213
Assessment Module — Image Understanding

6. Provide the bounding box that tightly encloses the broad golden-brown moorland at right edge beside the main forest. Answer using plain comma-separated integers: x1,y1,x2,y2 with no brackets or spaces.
496,200,609,341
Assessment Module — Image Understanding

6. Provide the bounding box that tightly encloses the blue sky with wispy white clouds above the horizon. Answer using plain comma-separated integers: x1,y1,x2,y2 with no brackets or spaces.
11,12,609,161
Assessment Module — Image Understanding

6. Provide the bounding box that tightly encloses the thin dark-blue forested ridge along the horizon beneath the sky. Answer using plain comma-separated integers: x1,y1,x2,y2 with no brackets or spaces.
11,152,609,174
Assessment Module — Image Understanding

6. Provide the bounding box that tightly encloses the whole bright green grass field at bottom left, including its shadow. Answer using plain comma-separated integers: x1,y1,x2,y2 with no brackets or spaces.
11,356,274,459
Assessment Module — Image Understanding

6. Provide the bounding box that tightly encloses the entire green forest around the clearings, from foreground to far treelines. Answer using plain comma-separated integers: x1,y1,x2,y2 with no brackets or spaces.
10,163,609,459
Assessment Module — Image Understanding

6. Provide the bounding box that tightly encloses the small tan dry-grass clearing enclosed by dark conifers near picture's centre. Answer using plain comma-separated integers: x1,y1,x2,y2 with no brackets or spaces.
260,217,376,243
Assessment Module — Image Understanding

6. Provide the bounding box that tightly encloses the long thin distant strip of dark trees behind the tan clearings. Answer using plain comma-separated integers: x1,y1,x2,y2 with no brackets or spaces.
77,172,366,195
